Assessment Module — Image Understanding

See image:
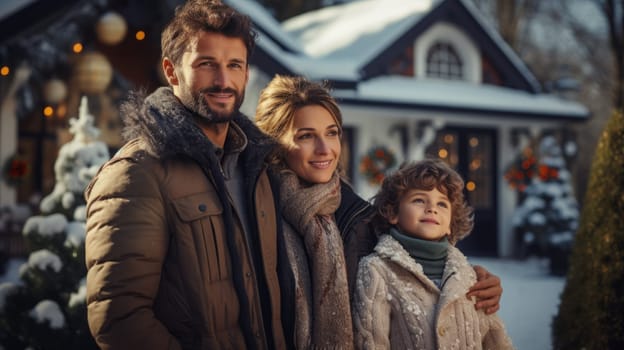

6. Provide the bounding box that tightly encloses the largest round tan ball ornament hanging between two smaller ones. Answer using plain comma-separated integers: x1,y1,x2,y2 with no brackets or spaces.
75,52,113,95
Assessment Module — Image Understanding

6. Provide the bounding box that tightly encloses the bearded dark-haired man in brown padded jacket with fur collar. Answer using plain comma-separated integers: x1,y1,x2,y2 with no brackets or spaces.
85,0,284,349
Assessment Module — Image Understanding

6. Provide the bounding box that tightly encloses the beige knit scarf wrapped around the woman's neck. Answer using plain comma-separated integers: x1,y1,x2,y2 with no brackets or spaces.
280,170,353,349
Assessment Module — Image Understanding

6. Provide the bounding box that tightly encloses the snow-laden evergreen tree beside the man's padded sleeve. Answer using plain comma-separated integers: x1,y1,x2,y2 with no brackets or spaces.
0,97,109,349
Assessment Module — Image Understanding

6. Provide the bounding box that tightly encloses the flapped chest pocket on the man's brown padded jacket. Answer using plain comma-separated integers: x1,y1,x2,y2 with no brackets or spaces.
173,192,230,281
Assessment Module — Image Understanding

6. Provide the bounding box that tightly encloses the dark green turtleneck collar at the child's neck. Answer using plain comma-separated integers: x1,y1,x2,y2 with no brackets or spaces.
390,227,449,281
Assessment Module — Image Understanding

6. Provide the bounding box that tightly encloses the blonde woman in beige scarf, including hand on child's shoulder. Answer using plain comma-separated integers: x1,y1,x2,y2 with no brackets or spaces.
255,75,502,349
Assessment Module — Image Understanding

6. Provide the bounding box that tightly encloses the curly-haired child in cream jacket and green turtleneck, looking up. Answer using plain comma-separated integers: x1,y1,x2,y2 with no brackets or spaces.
353,160,513,350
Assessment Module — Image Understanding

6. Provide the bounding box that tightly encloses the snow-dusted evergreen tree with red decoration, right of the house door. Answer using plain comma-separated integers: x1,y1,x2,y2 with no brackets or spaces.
513,135,579,275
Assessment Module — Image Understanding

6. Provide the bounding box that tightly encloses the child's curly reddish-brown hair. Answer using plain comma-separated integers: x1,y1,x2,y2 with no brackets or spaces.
373,159,474,244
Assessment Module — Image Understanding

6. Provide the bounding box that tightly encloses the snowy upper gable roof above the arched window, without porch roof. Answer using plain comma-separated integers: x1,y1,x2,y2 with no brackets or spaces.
283,0,540,93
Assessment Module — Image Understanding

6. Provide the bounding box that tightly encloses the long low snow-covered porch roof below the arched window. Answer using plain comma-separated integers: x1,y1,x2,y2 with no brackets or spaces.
334,76,589,120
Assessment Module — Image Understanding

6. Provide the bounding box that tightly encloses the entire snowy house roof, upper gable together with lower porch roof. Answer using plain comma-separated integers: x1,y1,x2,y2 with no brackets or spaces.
283,0,589,121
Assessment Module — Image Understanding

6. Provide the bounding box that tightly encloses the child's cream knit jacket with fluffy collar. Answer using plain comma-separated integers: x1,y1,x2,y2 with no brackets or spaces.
353,235,513,350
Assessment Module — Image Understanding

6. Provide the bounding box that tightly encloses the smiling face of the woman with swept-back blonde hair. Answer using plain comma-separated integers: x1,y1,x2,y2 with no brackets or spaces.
282,105,341,183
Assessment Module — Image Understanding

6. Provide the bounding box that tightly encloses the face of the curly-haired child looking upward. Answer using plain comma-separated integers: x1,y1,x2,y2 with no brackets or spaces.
389,188,451,241
